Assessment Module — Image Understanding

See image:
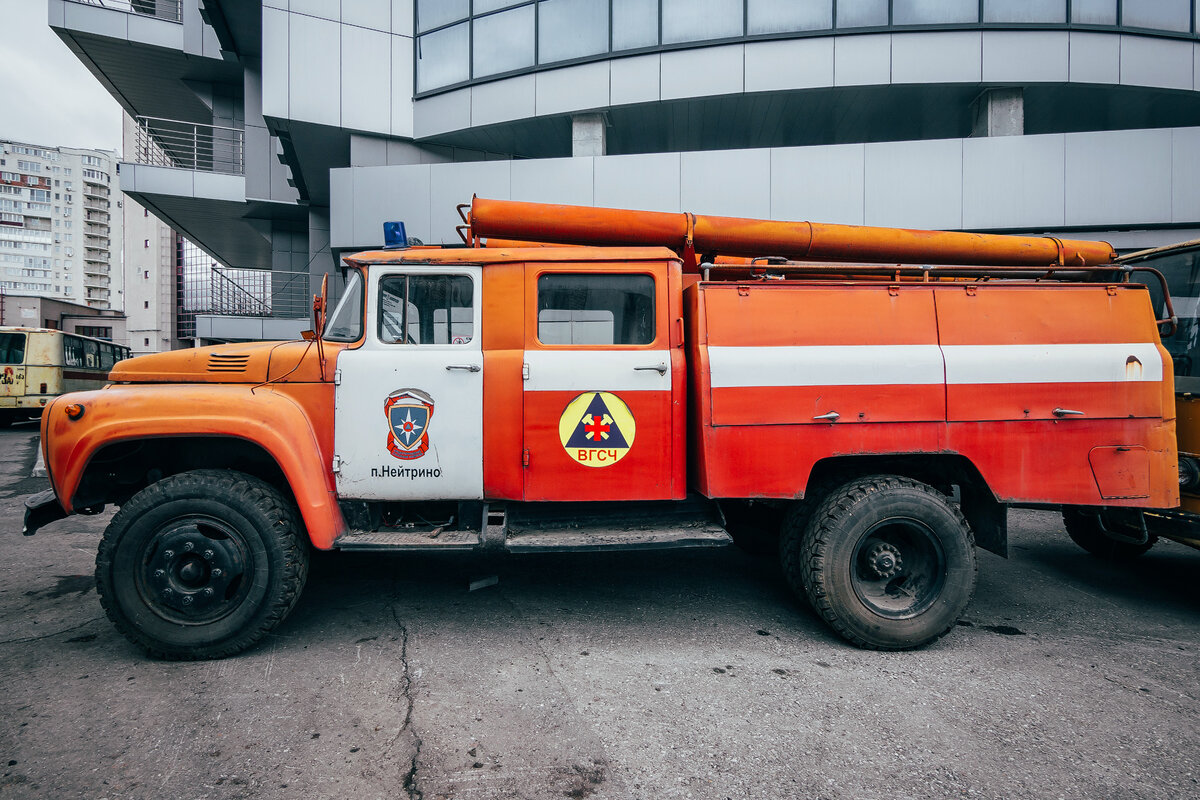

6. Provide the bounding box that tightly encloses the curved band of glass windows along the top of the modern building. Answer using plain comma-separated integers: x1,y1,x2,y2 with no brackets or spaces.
415,0,1200,95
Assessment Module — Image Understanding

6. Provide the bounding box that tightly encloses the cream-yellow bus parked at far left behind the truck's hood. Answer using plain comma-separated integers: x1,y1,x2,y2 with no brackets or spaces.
0,326,130,428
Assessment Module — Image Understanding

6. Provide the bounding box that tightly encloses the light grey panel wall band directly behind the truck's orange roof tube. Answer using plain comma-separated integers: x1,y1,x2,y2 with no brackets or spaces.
333,128,1200,247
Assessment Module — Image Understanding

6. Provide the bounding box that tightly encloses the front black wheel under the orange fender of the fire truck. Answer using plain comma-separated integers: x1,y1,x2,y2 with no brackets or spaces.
96,470,308,660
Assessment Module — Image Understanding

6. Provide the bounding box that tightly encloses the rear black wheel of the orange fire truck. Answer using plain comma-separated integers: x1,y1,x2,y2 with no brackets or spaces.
780,475,978,650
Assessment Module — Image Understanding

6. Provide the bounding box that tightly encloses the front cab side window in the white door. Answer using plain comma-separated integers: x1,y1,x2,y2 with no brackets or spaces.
379,275,475,344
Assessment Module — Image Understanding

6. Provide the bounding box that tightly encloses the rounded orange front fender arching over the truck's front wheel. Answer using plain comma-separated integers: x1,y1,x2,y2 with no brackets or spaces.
42,384,346,549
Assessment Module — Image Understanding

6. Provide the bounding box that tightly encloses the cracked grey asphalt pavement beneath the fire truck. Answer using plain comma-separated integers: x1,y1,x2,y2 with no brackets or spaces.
0,425,1200,800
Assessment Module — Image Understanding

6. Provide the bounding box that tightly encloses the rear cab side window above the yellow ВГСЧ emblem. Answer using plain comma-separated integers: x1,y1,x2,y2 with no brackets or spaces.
538,272,655,345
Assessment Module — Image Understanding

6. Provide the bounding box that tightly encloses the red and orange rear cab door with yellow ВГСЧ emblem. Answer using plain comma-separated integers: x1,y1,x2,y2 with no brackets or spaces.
522,263,684,501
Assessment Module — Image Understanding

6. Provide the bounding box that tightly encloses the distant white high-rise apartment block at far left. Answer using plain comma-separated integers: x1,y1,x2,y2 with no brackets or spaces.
0,140,124,311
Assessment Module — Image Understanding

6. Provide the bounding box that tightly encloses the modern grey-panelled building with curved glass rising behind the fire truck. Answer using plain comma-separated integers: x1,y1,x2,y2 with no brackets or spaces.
49,0,1200,326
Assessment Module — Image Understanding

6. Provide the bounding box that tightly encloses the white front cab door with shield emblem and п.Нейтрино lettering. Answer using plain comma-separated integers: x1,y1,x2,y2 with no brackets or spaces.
334,265,484,500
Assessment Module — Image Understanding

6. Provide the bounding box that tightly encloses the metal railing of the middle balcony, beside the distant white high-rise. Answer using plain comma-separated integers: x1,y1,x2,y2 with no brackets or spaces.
133,116,246,175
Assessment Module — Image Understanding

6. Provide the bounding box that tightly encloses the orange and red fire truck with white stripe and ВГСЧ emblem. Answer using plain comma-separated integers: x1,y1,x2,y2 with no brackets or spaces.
26,199,1178,658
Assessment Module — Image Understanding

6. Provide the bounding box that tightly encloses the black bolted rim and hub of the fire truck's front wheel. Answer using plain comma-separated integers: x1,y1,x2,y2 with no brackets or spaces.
142,519,246,622
